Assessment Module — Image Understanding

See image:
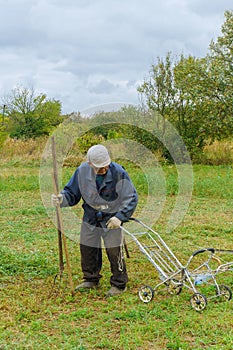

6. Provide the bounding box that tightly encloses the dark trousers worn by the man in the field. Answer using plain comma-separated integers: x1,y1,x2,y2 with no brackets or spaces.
80,223,128,289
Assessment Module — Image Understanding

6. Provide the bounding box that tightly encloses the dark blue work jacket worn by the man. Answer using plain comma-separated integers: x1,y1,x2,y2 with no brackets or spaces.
61,162,138,228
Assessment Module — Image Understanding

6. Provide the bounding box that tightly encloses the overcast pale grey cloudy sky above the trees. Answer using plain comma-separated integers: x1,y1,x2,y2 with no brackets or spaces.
0,0,233,113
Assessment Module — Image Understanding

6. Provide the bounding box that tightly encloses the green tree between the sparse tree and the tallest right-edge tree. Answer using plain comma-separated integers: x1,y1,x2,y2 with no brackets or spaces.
170,55,213,152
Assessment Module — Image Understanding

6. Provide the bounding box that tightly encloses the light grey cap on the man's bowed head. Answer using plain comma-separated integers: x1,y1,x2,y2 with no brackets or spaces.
87,145,111,168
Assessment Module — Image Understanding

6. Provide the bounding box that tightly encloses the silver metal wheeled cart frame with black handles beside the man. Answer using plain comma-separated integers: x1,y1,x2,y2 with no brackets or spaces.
122,218,233,311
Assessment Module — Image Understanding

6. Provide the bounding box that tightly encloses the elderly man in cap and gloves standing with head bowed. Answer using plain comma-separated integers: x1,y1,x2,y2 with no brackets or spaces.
52,145,138,296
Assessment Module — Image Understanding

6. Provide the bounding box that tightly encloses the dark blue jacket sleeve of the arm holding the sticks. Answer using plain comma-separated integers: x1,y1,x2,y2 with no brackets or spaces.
61,169,81,207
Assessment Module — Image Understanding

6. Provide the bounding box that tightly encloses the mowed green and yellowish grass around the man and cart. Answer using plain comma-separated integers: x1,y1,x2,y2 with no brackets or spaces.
0,163,233,350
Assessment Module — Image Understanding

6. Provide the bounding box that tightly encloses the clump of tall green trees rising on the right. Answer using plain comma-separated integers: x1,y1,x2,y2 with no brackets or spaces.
138,11,233,159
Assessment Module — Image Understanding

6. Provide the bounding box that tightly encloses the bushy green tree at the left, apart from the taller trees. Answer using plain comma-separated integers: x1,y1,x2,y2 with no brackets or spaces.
4,87,63,138
